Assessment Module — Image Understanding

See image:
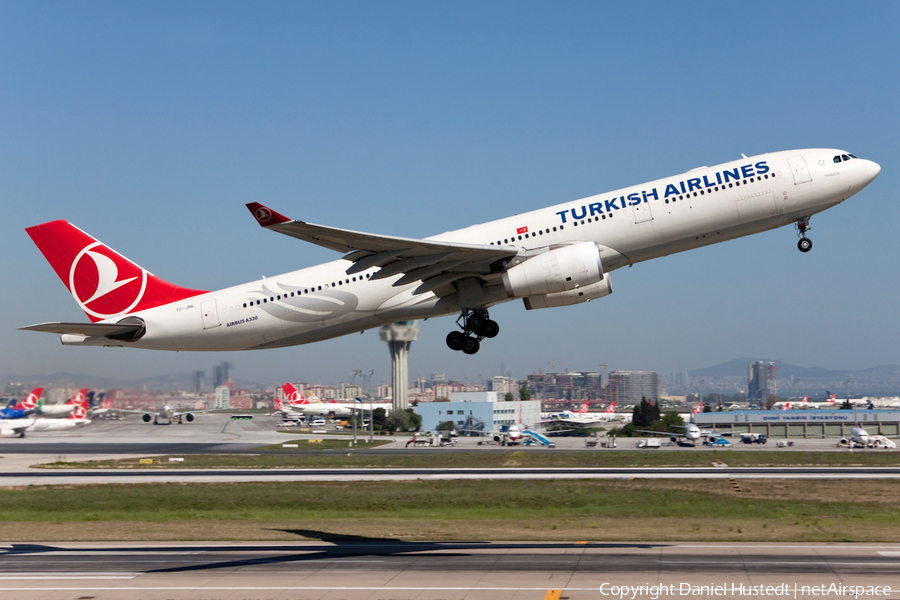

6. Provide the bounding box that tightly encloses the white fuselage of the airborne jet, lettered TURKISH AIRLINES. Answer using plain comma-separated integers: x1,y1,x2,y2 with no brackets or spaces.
68,149,880,352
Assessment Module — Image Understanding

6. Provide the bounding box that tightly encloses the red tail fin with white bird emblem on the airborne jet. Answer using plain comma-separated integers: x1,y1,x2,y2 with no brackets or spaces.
25,221,204,323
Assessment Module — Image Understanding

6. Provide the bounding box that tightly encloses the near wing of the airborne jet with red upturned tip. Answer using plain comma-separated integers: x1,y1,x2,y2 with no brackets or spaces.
247,202,518,294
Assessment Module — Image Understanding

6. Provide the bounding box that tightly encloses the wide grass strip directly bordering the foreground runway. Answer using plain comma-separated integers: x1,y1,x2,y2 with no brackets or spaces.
0,480,900,542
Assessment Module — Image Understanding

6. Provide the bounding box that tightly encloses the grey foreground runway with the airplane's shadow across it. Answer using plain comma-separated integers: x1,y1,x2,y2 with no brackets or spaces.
0,531,900,600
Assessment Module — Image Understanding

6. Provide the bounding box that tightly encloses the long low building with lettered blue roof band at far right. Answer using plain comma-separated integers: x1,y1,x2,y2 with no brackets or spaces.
694,409,900,439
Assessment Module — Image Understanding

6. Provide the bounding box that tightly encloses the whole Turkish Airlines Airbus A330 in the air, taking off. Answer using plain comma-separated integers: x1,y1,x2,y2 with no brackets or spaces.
22,149,881,354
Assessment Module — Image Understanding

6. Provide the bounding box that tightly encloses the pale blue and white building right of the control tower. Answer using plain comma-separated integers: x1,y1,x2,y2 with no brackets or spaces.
416,392,541,435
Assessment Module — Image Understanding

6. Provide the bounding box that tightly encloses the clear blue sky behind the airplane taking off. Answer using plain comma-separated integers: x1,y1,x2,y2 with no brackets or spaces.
0,2,900,382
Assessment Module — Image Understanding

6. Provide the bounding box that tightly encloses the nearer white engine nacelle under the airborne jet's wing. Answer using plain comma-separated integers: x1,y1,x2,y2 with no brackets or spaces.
503,242,603,298
